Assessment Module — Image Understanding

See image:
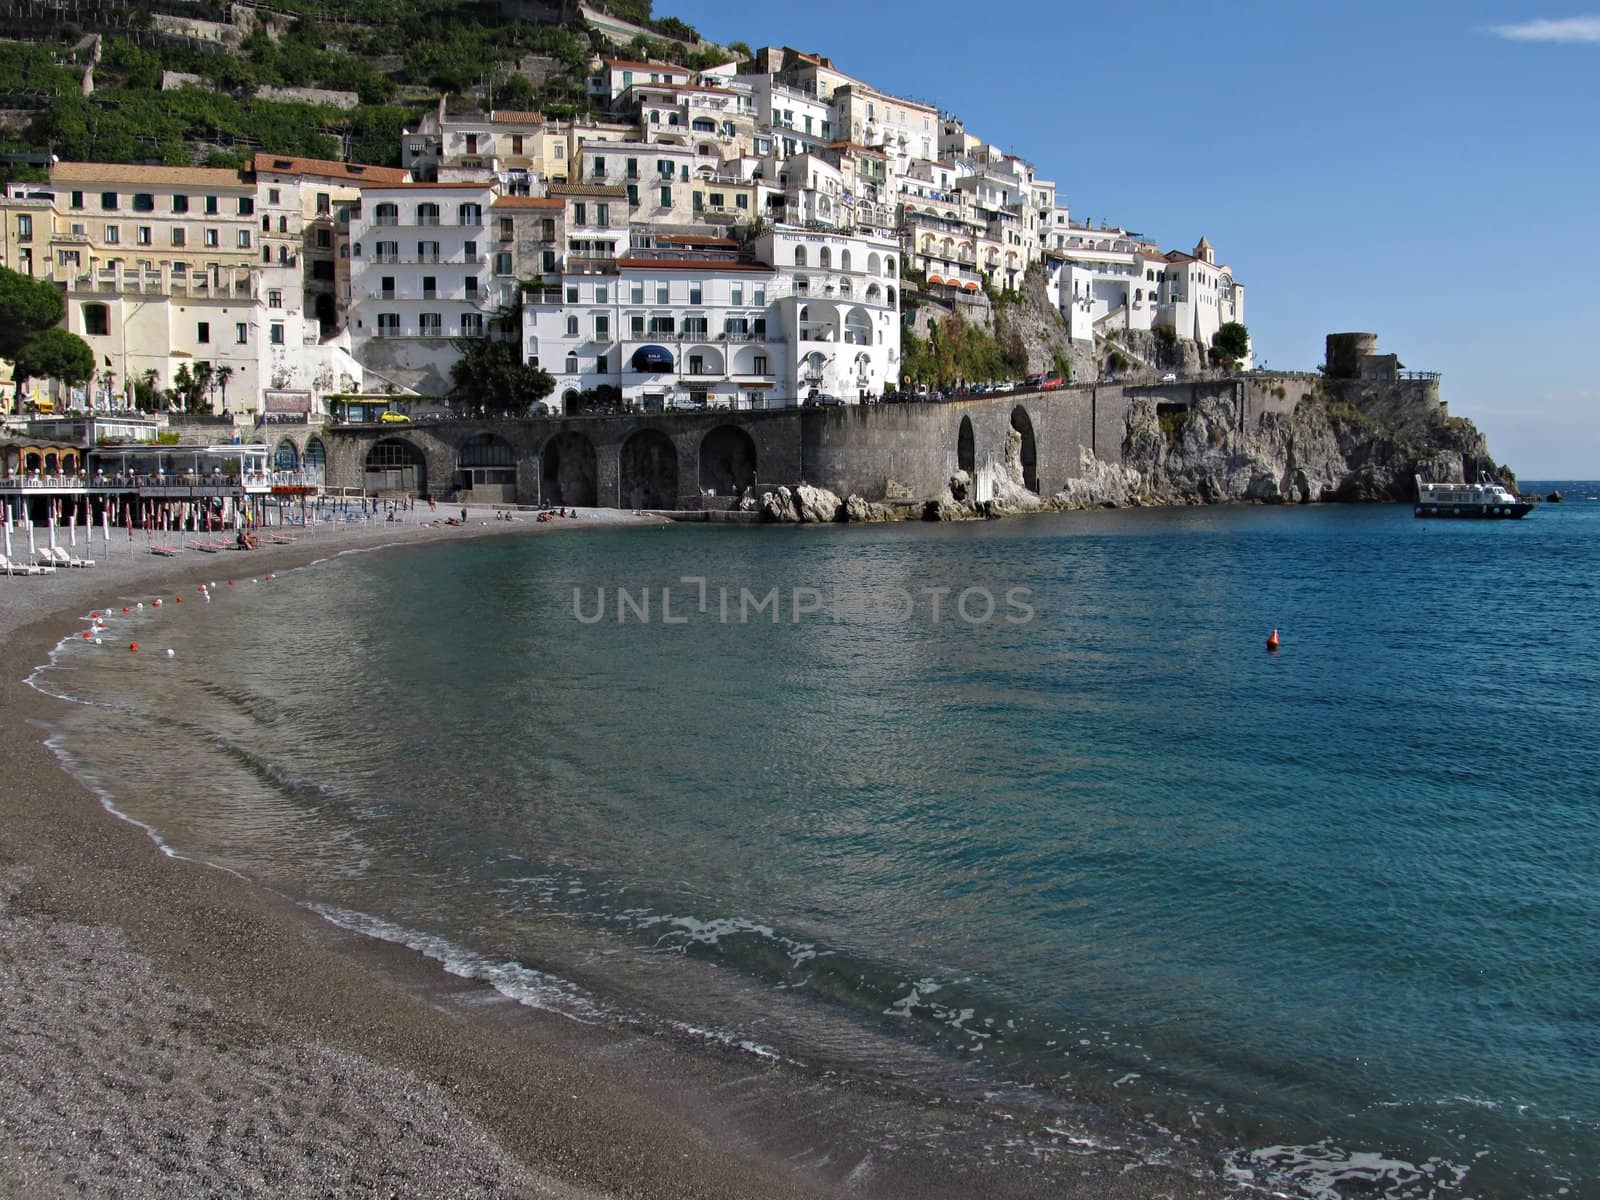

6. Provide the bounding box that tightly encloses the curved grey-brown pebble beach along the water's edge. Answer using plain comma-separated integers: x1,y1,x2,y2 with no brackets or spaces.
0,514,1226,1198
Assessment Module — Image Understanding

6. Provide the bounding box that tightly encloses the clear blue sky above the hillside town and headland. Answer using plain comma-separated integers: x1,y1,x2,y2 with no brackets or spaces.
654,0,1600,478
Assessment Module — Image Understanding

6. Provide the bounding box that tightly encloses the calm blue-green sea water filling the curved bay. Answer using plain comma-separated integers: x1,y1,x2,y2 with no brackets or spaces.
37,483,1600,1197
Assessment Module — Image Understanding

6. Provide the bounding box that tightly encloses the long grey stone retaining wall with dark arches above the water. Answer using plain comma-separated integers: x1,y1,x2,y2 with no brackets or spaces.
320,382,1272,509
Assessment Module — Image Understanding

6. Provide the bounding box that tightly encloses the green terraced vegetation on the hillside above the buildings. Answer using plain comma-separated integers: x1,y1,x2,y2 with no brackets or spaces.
0,0,726,178
